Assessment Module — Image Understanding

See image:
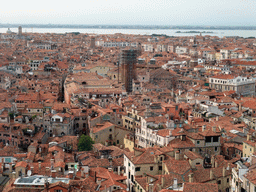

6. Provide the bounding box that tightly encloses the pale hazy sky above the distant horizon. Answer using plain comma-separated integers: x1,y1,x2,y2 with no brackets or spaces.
0,0,256,26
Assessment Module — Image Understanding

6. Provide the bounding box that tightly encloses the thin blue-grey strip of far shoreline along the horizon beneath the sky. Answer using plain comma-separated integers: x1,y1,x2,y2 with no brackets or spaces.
0,24,256,30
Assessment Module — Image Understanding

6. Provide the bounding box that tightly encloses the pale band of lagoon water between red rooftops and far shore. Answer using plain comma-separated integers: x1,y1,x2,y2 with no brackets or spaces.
0,28,256,37
